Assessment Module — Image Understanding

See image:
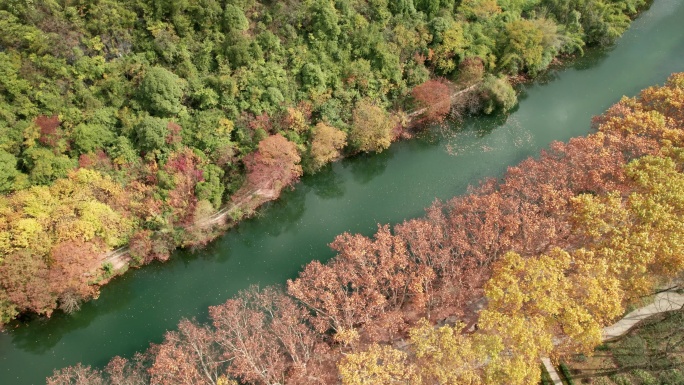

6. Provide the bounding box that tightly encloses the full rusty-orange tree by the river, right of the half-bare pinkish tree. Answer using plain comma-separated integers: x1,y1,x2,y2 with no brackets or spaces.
288,226,408,333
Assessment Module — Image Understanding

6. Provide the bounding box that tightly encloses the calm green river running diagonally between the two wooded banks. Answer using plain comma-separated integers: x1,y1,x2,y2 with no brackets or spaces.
0,0,684,385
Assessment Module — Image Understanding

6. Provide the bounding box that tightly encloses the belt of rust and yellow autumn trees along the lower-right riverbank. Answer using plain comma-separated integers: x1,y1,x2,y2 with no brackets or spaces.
48,74,684,385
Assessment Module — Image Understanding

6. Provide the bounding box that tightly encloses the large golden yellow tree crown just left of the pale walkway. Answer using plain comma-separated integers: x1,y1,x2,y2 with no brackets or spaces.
478,249,622,384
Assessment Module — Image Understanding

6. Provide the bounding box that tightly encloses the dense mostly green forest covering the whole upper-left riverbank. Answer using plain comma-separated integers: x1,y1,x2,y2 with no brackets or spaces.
0,0,645,323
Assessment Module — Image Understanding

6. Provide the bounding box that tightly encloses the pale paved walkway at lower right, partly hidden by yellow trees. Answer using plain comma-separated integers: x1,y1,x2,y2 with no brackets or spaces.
542,289,684,385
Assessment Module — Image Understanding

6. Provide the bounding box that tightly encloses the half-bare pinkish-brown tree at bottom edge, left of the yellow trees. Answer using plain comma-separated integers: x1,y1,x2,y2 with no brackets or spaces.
209,288,330,385
